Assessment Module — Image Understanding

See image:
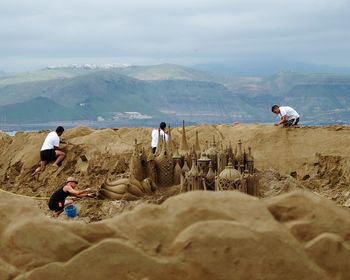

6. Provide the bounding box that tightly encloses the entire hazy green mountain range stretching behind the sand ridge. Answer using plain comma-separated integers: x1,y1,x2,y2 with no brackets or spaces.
0,64,350,124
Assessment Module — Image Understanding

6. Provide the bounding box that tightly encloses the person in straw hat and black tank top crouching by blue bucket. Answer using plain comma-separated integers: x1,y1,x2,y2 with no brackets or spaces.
48,177,93,217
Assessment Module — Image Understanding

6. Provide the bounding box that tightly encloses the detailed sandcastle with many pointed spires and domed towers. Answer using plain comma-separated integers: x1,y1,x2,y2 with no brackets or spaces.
100,122,259,200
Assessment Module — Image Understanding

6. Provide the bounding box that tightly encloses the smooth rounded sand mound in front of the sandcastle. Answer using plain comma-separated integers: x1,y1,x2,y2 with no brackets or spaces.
0,191,350,280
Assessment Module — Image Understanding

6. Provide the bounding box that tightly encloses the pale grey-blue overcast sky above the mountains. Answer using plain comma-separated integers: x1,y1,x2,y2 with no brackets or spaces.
0,0,350,71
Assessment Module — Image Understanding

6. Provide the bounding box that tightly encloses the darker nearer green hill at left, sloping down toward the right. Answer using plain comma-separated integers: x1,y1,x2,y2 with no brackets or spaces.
0,71,252,123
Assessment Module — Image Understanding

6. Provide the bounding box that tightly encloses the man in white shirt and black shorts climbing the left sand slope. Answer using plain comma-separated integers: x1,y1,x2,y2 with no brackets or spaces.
34,126,66,174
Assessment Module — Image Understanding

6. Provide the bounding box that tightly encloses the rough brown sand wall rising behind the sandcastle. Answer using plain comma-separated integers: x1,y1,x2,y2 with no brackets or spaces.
0,125,350,196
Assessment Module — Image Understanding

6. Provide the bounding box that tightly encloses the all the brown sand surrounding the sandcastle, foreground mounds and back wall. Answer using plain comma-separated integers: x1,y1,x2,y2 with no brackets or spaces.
0,125,350,280
